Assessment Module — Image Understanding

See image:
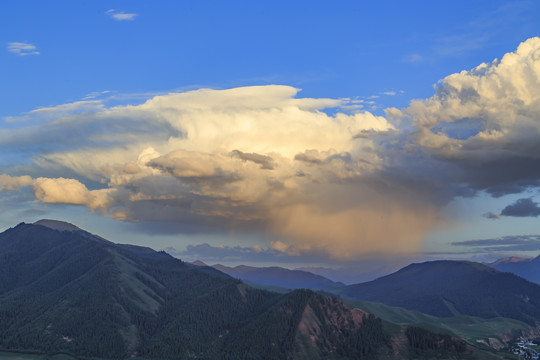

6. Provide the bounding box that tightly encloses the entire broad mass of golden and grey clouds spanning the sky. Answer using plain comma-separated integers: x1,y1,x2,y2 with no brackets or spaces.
0,38,540,258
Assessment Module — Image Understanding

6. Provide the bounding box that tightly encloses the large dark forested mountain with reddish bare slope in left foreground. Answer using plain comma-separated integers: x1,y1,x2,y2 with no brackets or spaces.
0,220,477,359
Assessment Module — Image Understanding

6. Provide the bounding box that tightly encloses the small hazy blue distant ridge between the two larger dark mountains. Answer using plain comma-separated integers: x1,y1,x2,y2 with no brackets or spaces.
209,264,345,290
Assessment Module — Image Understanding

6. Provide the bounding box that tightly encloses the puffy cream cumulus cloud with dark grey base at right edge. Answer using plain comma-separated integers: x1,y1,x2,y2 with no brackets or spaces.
387,38,540,196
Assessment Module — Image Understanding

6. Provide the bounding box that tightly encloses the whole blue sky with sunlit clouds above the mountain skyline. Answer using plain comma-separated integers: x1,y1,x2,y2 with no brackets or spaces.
0,0,540,280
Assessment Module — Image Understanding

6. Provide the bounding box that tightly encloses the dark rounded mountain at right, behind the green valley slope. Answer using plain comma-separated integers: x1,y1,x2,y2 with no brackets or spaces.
340,261,540,325
